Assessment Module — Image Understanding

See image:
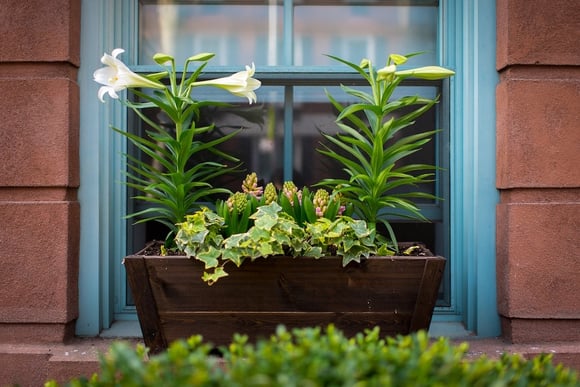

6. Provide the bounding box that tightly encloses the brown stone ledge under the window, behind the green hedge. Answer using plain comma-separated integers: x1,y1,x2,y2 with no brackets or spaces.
0,338,580,386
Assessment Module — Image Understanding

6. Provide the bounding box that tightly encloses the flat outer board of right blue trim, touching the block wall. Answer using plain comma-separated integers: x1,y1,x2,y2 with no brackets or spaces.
472,1,501,336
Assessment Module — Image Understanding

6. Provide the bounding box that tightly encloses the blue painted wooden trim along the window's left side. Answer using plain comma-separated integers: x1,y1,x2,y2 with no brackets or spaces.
76,0,136,336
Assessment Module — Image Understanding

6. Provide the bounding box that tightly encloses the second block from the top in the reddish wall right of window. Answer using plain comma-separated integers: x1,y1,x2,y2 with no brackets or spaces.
497,75,580,189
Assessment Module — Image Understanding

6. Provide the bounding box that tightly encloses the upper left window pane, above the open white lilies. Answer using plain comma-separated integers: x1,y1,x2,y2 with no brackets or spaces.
139,1,283,66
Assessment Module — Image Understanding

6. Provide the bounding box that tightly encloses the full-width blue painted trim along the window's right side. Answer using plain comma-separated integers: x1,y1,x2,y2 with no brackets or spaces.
442,0,500,337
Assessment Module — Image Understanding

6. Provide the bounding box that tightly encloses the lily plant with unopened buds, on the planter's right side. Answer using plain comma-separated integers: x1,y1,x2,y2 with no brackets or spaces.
318,55,453,244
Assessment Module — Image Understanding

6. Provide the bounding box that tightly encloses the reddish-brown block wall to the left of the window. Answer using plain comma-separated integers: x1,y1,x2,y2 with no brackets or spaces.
0,0,80,384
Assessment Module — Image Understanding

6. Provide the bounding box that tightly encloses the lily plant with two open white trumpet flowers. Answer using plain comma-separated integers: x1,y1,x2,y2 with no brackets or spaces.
93,48,260,246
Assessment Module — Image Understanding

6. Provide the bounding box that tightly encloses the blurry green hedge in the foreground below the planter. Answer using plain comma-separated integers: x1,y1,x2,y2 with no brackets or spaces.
47,326,580,387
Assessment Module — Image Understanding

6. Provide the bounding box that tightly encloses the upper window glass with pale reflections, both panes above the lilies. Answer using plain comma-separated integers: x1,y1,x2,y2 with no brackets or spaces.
139,0,438,66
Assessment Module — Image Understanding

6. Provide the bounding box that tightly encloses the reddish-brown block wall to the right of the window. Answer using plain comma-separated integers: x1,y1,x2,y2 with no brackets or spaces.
497,0,580,343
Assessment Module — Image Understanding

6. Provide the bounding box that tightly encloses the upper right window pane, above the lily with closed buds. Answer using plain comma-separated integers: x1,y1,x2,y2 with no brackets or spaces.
294,1,437,65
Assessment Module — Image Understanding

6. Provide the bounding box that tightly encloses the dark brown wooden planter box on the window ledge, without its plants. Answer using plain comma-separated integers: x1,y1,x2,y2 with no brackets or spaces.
124,255,445,353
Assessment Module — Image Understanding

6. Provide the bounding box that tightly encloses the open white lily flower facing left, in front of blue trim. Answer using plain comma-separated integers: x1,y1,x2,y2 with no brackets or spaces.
93,48,165,102
